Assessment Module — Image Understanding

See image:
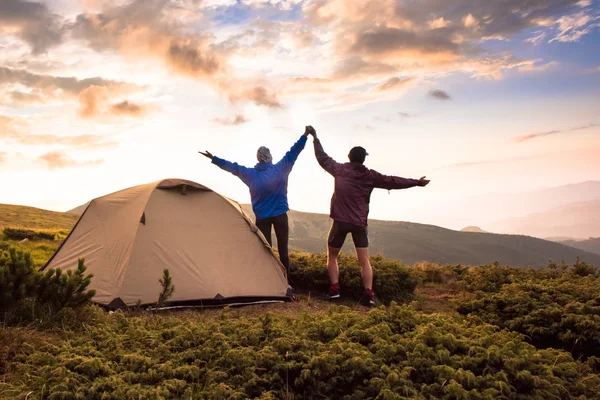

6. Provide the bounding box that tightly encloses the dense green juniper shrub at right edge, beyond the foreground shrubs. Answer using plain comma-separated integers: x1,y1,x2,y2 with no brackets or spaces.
458,262,600,357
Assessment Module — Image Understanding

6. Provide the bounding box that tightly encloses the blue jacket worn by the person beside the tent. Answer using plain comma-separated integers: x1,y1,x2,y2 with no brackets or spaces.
212,135,306,219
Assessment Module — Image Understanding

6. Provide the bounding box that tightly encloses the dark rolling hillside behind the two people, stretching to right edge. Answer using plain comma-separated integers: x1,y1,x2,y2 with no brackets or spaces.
243,205,600,266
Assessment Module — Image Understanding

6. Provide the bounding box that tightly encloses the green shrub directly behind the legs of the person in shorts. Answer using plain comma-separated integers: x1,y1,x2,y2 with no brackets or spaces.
290,253,418,304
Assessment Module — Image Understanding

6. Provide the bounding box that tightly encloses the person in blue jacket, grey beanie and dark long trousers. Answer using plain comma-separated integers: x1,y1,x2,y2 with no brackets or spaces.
199,129,308,276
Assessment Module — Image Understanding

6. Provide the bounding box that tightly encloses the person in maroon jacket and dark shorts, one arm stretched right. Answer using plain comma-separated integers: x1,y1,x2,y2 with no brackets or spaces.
308,126,429,307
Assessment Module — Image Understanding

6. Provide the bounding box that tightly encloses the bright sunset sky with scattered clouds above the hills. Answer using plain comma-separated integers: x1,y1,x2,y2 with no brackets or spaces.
0,0,600,229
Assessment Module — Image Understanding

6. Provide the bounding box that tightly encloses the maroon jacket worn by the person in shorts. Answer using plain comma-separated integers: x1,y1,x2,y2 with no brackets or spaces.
314,139,419,226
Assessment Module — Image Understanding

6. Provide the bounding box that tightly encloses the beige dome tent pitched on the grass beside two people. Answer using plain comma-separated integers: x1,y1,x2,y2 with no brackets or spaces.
43,179,291,309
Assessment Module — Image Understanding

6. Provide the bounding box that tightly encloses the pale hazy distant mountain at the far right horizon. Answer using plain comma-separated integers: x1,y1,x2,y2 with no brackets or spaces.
489,199,600,238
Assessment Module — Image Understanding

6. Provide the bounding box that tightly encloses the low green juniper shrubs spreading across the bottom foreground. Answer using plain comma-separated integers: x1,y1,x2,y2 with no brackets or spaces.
0,304,600,400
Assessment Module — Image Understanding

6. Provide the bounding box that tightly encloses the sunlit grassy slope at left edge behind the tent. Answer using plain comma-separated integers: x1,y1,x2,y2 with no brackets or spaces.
0,204,79,229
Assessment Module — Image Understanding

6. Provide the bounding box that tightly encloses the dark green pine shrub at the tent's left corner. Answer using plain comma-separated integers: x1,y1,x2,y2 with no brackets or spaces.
0,247,95,324
